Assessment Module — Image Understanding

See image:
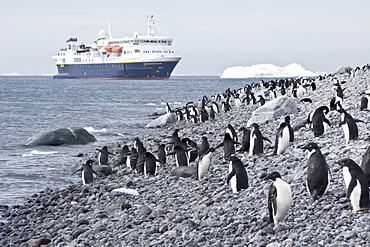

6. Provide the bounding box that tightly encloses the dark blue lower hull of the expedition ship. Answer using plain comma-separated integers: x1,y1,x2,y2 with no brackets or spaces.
53,61,179,80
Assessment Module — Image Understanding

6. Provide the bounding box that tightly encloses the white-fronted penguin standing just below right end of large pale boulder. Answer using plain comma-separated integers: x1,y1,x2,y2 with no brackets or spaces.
274,116,294,155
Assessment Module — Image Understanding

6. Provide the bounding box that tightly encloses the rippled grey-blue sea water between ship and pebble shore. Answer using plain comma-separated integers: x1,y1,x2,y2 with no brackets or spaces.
0,76,259,205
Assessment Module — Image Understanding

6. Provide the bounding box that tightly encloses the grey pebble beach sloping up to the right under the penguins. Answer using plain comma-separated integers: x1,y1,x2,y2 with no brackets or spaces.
0,65,370,247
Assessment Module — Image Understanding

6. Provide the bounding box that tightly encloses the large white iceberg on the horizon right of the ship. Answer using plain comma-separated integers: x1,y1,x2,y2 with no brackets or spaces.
220,63,319,78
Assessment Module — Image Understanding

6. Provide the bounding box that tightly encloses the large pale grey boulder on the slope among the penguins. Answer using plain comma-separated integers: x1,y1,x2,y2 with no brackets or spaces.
247,96,299,126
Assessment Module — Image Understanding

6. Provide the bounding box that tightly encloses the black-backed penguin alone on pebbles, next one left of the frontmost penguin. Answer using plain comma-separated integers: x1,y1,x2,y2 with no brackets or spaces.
226,155,248,193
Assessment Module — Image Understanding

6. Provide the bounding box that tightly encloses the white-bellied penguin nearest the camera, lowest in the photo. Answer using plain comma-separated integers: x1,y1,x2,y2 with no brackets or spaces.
266,172,292,225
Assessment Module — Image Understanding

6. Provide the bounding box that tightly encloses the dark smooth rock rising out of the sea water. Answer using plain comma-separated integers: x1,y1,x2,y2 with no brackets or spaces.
25,127,96,146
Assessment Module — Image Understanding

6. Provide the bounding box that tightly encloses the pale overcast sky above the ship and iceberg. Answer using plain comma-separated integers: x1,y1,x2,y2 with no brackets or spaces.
0,0,370,75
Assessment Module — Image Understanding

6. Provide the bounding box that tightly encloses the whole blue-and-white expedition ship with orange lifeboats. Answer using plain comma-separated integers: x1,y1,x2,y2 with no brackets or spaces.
52,15,181,80
